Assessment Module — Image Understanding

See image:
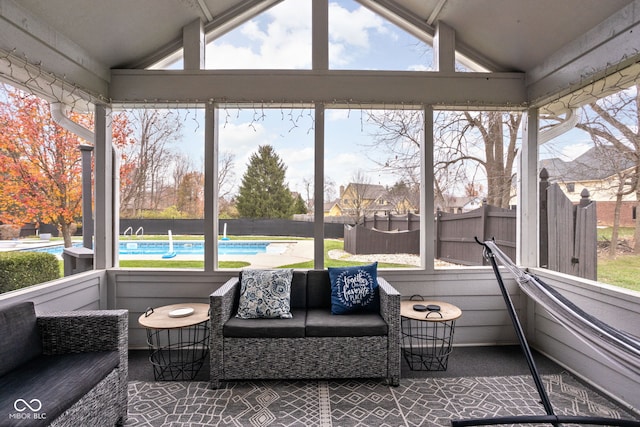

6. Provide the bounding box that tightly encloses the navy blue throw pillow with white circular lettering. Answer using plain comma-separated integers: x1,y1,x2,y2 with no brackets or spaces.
329,262,380,314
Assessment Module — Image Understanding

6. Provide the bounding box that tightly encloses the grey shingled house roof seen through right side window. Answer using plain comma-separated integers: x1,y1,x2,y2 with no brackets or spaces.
540,145,635,182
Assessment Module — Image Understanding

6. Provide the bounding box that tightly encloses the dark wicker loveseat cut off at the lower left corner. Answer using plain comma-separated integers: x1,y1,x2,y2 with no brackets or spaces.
0,302,128,426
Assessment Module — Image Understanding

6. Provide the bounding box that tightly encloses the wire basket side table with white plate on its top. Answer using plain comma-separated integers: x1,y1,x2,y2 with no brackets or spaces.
138,303,209,381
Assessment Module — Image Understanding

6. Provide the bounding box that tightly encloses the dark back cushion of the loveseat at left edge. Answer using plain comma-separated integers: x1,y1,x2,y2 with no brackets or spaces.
0,301,42,376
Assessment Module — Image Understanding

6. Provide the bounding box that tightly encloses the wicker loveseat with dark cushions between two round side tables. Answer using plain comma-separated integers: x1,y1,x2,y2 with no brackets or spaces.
210,270,400,388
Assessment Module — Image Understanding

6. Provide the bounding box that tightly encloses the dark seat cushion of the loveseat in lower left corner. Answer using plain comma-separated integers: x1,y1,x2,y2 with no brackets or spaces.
0,351,120,426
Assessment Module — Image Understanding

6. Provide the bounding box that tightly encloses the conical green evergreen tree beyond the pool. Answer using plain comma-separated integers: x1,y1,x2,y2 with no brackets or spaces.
237,145,294,218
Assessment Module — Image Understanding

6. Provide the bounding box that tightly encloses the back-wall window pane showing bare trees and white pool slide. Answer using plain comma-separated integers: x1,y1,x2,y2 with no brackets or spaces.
114,106,205,269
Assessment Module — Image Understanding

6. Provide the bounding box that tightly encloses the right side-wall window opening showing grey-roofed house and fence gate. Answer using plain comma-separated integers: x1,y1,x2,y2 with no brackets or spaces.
538,83,640,289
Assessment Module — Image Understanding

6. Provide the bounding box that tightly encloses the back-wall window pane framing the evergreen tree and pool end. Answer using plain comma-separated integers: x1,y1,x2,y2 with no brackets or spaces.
217,104,316,268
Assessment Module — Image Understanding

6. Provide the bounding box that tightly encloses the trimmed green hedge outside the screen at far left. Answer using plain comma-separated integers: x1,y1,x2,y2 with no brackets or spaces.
0,251,60,293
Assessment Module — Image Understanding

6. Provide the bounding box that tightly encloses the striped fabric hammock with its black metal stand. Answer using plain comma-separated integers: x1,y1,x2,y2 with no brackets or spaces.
451,239,640,427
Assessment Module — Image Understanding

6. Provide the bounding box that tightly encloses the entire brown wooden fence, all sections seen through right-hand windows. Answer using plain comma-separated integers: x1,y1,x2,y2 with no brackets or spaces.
344,169,597,280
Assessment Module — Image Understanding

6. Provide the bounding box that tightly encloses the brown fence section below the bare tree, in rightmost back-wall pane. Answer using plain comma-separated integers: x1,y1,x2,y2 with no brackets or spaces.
435,203,516,265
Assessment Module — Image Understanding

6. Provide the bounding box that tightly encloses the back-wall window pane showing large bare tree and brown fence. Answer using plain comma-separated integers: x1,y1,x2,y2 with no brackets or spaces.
434,111,522,267
